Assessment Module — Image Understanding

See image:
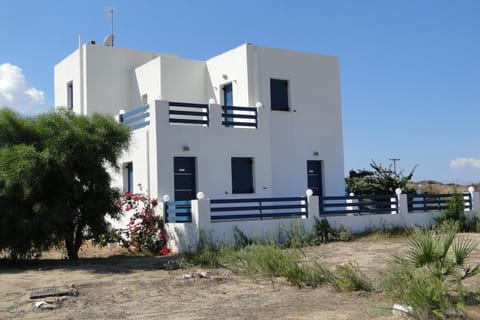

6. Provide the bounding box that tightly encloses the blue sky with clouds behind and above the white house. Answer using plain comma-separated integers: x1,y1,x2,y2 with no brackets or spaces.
0,0,480,183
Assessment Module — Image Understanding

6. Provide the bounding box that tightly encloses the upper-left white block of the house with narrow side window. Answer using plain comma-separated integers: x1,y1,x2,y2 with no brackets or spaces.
55,44,165,115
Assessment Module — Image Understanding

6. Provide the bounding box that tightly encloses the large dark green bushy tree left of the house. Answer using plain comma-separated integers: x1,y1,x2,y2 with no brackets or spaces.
0,109,130,260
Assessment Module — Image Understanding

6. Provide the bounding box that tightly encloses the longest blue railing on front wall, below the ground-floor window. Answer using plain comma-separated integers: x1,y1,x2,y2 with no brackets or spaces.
210,197,308,222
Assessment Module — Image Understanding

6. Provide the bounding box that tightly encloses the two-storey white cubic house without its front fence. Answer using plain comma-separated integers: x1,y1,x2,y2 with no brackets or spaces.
55,43,344,204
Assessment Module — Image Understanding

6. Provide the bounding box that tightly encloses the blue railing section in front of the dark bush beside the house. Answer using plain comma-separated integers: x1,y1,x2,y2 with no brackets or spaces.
319,194,398,215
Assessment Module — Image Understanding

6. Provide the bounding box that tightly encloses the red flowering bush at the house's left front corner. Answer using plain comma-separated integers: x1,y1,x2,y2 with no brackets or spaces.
117,185,170,255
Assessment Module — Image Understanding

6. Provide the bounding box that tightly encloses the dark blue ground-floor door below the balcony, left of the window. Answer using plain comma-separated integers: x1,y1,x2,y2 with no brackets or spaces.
173,157,197,201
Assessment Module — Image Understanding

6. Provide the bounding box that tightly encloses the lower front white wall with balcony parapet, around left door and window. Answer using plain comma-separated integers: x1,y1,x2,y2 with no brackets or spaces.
151,101,272,200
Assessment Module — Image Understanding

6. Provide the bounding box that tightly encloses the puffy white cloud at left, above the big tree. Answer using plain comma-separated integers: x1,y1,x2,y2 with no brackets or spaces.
0,62,47,114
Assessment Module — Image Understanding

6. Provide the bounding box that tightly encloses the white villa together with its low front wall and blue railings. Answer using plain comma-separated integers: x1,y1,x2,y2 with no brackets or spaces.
55,39,480,251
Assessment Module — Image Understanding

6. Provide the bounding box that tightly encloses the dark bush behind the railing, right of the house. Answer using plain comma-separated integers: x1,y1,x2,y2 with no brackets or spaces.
345,161,417,195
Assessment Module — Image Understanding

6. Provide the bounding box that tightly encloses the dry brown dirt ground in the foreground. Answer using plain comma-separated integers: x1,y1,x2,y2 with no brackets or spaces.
0,234,480,320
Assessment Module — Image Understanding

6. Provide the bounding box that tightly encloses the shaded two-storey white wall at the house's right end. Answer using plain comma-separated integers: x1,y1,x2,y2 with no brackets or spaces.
249,46,344,195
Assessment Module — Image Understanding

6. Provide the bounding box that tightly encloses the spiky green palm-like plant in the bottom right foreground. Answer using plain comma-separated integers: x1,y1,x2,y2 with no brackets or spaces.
385,223,480,319
